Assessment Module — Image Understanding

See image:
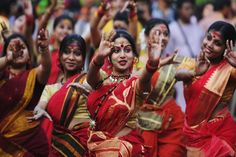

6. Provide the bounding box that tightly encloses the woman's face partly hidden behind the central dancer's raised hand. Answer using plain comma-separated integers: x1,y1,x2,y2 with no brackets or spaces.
147,24,169,51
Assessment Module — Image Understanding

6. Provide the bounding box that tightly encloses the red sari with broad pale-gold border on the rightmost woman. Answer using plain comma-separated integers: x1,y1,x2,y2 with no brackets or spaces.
183,61,236,157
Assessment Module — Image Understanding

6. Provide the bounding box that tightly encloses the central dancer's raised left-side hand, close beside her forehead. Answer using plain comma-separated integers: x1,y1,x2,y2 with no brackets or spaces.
98,30,116,59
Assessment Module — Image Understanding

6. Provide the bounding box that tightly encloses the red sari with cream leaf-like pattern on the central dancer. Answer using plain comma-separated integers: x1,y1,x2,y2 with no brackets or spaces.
88,77,144,157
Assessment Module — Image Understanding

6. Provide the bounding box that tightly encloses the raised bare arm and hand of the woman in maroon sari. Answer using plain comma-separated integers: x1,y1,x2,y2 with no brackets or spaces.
37,29,51,84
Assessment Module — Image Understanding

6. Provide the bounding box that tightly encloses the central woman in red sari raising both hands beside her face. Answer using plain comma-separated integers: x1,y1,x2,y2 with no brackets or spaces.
87,30,161,157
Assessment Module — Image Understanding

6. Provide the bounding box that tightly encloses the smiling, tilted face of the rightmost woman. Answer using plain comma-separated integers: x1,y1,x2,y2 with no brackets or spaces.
202,31,225,60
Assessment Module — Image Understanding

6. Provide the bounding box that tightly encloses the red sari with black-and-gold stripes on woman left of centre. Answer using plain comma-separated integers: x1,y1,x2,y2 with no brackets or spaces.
47,74,89,157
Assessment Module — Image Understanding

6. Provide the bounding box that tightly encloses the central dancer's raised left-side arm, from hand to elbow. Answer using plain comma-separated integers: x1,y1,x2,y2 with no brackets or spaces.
87,31,115,89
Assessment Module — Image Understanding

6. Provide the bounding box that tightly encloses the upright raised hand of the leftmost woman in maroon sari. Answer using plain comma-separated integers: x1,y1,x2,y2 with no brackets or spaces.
37,28,49,53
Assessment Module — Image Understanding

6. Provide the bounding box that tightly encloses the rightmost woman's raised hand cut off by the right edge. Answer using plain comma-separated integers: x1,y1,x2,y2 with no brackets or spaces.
224,40,236,67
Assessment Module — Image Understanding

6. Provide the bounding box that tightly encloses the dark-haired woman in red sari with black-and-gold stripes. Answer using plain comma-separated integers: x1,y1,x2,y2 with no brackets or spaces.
31,34,89,157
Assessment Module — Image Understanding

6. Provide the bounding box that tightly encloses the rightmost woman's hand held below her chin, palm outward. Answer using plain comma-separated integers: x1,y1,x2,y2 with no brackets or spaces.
195,51,210,76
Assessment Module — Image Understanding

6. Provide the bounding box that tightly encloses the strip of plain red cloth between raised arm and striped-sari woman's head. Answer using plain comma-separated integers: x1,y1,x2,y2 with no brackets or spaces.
48,50,61,84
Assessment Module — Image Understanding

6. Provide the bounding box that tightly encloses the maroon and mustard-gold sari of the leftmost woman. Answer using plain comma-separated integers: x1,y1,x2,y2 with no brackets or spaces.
0,69,48,156
